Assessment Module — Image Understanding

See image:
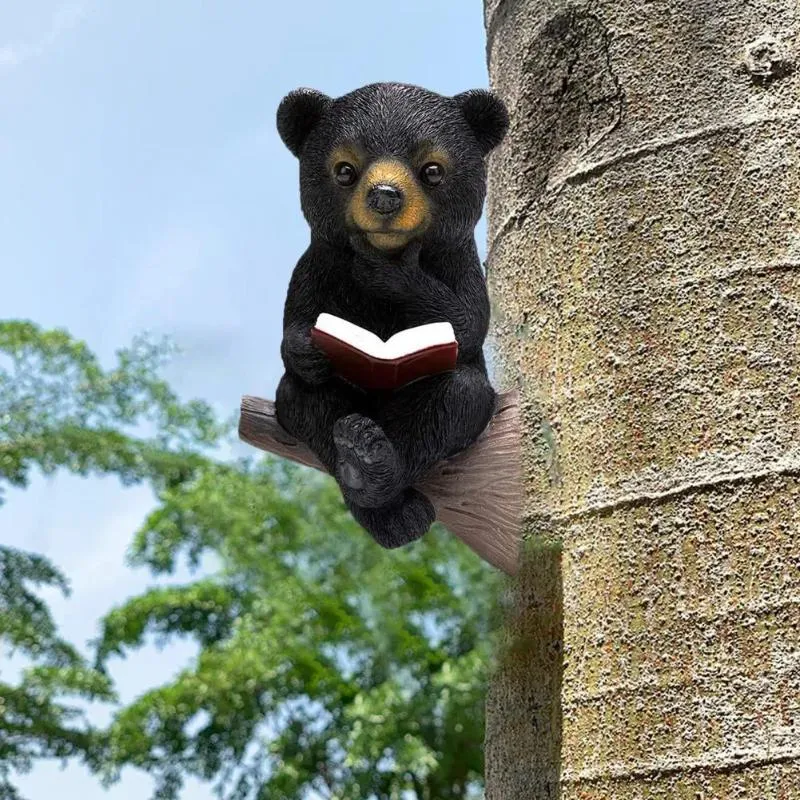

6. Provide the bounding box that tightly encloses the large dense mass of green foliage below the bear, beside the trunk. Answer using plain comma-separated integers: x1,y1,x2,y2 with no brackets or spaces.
98,459,498,800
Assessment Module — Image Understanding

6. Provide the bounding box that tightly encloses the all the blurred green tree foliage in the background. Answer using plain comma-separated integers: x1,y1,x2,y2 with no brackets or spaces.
0,323,499,800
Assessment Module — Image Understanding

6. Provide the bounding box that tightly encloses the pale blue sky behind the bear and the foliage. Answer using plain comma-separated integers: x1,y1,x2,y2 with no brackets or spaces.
0,0,488,800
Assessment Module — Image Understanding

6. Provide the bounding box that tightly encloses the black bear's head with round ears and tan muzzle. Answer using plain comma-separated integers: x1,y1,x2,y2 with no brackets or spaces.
277,83,508,252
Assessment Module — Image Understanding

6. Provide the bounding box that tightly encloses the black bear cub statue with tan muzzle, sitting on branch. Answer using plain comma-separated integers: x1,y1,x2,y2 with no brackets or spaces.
275,83,509,547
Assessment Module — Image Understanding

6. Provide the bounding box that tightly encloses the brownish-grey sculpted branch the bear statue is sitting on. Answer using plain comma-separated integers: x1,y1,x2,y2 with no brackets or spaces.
239,392,522,575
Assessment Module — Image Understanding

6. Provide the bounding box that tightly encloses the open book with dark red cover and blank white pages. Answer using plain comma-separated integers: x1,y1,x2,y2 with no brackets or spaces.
311,314,458,389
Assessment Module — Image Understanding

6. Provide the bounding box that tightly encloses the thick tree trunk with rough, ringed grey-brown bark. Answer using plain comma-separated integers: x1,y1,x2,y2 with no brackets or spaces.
486,0,800,800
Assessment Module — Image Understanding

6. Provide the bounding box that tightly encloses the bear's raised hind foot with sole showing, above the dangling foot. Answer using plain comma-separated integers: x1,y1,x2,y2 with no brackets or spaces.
333,414,403,508
